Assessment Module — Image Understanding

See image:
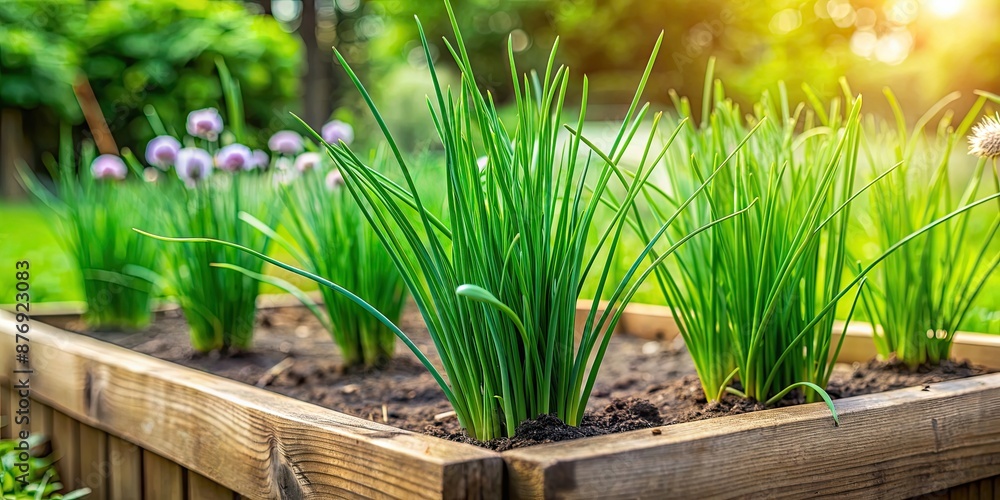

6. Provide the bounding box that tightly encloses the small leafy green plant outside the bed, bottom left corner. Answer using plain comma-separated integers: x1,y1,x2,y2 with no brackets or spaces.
0,435,90,500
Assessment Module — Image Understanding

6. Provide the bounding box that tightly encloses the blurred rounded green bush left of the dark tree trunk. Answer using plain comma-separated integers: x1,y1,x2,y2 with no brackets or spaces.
0,0,302,151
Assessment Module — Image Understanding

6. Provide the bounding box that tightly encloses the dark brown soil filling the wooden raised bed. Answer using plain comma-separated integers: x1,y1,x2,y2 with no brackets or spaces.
58,307,985,450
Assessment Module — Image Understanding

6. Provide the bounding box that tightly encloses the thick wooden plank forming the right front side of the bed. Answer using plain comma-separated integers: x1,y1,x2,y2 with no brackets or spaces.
503,373,1000,498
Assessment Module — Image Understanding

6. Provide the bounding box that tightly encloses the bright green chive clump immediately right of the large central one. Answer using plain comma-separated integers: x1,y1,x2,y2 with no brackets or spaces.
639,71,988,419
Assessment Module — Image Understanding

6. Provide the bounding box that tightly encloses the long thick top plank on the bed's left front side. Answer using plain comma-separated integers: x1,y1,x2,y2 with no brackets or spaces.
0,312,503,498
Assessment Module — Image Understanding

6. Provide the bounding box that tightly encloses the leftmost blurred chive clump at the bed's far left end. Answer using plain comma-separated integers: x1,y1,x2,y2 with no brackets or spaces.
21,127,157,330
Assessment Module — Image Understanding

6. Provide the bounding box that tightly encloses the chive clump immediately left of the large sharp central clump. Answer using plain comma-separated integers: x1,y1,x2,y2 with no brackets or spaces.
236,148,407,368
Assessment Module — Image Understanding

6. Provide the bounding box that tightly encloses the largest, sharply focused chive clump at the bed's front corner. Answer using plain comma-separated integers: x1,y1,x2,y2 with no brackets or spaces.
143,3,752,439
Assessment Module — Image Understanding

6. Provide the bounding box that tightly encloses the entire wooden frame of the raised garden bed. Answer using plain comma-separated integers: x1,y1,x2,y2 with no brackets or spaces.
0,299,1000,499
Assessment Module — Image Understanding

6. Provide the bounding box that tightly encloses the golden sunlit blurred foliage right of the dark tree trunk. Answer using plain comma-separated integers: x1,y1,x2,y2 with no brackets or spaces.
366,0,1000,119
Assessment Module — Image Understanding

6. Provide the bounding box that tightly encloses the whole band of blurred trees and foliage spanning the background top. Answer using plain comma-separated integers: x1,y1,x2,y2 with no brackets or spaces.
0,0,1000,154
